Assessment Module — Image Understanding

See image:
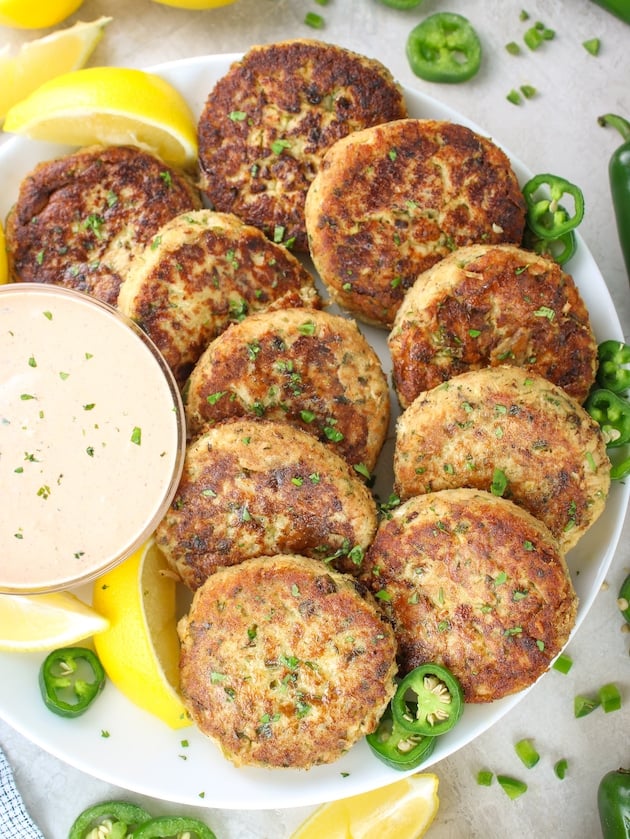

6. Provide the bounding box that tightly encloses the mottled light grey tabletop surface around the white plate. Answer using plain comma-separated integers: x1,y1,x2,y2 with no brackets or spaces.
0,0,630,839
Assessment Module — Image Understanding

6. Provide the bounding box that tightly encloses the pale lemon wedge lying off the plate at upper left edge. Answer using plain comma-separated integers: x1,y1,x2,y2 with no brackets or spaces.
0,16,112,121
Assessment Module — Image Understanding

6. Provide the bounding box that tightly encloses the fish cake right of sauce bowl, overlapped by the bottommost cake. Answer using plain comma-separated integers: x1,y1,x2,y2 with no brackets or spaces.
156,418,376,589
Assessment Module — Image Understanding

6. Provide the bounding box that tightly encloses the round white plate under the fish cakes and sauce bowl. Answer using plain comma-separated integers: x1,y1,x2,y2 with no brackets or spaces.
0,55,630,810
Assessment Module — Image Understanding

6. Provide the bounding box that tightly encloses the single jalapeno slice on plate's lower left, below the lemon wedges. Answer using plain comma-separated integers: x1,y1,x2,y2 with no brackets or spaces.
39,647,105,717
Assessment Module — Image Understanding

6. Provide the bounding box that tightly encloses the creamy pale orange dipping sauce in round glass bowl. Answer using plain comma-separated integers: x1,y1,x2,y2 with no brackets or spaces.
0,283,185,593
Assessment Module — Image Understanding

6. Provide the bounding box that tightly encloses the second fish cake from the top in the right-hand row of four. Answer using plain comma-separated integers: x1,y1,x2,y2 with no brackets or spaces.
388,245,597,408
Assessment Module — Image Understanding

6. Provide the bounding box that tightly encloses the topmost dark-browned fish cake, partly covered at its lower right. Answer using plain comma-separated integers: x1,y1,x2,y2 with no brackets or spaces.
198,39,407,251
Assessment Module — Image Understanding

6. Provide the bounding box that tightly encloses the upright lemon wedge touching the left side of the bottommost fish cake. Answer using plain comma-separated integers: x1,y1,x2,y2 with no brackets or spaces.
92,539,190,728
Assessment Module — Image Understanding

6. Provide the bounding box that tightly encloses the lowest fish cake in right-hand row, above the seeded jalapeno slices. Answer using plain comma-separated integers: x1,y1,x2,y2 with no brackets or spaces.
362,489,577,702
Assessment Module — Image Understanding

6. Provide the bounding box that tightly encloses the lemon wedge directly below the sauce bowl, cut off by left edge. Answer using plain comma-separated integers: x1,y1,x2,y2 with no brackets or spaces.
0,591,109,653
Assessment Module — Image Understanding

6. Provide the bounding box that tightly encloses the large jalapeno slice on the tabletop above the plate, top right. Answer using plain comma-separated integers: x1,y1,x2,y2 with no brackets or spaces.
407,12,481,84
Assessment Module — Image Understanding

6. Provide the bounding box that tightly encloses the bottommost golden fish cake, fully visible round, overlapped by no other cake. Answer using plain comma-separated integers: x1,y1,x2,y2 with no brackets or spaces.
179,556,396,769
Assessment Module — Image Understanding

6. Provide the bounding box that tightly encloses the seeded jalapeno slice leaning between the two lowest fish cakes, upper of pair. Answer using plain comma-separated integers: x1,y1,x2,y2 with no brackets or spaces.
392,663,464,737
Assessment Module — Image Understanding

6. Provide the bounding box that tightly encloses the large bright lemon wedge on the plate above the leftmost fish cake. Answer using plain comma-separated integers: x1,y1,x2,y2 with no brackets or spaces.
4,67,197,167
